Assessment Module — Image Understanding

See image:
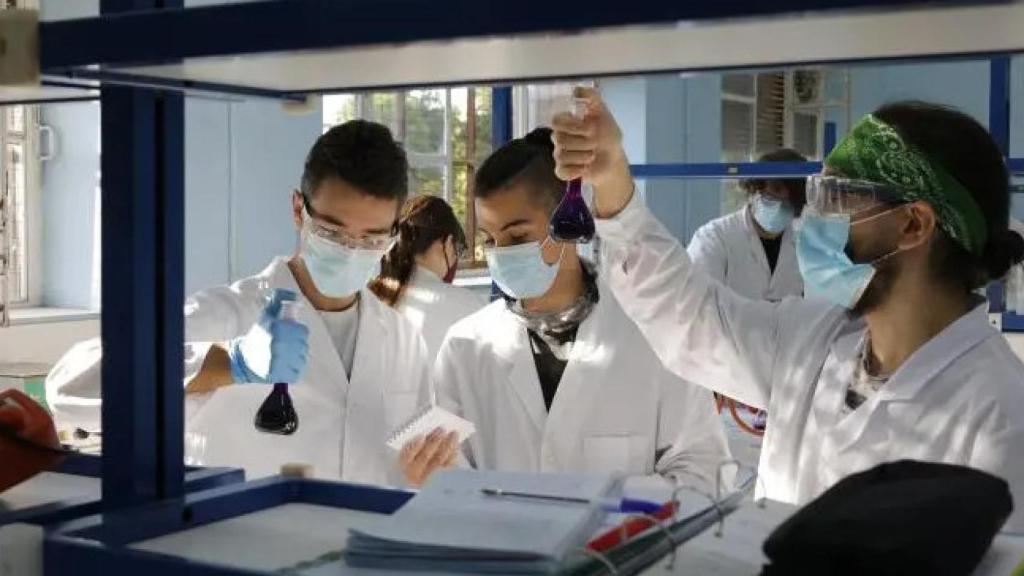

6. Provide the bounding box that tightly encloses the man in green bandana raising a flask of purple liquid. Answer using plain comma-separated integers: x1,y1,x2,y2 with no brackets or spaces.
555,89,1024,531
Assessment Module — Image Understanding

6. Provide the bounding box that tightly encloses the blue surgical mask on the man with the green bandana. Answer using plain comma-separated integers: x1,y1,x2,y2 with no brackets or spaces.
796,210,899,310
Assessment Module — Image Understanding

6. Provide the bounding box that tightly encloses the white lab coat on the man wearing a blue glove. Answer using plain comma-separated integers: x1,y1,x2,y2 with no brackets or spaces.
48,257,431,486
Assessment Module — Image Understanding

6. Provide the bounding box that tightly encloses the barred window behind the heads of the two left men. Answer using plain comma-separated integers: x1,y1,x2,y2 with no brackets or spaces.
324,87,492,261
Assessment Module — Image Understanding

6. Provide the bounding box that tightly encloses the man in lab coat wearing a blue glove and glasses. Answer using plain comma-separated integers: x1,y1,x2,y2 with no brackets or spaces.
47,121,436,485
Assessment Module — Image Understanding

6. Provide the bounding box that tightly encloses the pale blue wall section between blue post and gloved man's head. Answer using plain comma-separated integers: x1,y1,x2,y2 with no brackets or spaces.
185,99,323,293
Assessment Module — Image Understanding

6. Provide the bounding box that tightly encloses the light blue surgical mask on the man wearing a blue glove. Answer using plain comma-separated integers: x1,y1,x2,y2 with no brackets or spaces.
302,233,387,298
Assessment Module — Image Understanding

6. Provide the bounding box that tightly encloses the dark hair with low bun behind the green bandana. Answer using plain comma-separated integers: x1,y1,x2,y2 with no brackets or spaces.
874,100,1024,292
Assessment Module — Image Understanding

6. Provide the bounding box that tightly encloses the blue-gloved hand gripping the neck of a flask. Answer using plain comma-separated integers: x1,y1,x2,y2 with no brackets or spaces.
227,288,309,384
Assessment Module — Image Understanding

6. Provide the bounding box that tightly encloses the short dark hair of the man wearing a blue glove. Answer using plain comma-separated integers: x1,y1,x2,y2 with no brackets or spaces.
301,120,409,202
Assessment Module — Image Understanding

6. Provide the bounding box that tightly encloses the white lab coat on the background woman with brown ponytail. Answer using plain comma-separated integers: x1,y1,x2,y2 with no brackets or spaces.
398,265,487,362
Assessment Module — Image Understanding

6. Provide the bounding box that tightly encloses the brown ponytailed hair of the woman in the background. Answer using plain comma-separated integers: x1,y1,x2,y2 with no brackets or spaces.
370,196,466,306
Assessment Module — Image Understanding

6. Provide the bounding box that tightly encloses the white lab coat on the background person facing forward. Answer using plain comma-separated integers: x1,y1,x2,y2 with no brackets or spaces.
686,206,804,301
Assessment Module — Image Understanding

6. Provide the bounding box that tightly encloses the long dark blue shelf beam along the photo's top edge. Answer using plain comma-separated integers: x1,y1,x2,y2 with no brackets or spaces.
40,0,954,71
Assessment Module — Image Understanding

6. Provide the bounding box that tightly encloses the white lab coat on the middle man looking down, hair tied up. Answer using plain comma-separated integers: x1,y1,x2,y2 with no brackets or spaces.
434,278,729,490
